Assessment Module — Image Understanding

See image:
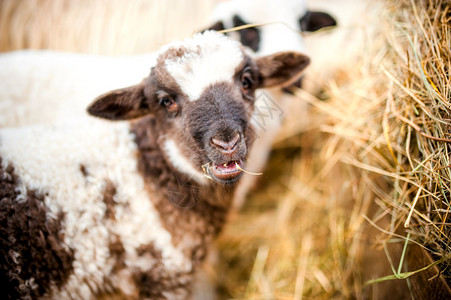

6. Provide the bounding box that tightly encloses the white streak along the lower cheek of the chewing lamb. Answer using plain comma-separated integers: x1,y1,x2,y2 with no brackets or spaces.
164,139,206,184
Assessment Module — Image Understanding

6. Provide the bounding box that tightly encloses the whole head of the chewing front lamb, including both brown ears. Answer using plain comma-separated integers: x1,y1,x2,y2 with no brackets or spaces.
88,31,309,183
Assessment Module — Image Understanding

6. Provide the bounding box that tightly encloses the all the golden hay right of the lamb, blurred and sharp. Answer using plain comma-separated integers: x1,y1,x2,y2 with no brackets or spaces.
218,0,451,299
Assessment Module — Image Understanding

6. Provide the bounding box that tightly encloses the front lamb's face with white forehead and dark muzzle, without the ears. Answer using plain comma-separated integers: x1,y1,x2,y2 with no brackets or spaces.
144,33,259,183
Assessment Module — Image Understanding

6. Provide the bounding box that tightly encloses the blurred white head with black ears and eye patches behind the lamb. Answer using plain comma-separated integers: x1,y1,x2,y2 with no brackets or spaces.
210,0,337,55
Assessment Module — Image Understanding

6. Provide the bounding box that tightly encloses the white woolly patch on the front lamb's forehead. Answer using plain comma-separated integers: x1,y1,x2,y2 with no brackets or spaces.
165,31,244,101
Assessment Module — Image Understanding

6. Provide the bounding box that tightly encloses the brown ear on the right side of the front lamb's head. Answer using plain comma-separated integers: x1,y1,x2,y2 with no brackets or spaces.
256,52,310,88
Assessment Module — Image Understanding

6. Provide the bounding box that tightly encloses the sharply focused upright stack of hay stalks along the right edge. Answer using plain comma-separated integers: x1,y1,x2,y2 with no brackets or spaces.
381,1,451,268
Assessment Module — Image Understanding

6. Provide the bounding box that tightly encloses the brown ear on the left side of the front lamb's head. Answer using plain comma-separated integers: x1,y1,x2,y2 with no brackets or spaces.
88,83,151,120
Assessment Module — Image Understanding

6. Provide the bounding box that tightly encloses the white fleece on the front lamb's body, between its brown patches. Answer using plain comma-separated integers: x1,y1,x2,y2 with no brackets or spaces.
0,120,192,299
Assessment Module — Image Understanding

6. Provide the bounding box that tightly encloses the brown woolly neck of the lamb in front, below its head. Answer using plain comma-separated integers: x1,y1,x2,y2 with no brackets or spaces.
132,118,234,261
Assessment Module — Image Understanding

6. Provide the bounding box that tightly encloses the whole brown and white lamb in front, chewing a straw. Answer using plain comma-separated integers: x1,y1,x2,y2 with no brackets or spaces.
0,31,309,299
